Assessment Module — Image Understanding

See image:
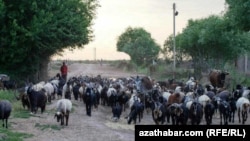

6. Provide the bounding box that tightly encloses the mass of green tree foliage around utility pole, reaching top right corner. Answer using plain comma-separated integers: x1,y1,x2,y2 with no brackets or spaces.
163,0,250,77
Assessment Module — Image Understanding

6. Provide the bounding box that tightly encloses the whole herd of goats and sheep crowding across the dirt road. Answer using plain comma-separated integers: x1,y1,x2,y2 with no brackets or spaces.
0,70,250,128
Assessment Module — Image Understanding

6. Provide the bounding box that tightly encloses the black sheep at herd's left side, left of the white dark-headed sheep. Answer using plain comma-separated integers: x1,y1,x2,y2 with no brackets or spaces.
27,86,47,114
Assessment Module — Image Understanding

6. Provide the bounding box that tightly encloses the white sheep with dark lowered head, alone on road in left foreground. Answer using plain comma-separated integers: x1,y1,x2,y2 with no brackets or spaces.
54,98,72,126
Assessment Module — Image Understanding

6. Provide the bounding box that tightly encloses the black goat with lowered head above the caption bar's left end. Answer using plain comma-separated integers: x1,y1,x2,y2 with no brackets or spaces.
127,100,144,124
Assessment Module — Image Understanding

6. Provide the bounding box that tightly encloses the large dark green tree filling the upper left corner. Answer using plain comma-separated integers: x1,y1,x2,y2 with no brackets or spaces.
0,0,98,82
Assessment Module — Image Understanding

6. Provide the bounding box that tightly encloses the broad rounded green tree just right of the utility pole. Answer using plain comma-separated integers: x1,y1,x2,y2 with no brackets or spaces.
170,15,249,77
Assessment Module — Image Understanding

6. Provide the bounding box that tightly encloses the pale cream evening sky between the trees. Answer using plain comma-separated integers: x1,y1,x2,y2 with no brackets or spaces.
53,0,225,60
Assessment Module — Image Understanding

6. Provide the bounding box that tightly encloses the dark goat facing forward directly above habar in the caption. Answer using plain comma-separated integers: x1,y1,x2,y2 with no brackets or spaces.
152,102,166,125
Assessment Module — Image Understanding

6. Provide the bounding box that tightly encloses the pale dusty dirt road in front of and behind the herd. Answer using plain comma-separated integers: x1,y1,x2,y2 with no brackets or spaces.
10,63,250,141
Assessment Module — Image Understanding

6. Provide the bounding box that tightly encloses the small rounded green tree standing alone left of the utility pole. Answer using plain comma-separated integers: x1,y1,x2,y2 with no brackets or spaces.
116,27,160,65
